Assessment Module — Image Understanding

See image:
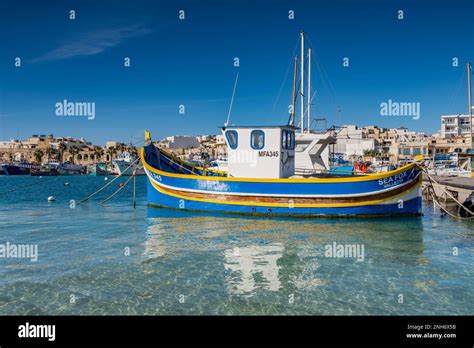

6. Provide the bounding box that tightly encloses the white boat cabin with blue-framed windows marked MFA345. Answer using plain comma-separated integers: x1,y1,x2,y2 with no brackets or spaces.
222,126,295,178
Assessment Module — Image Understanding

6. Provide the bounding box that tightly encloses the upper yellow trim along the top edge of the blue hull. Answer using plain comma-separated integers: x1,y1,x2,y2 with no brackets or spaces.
140,148,416,184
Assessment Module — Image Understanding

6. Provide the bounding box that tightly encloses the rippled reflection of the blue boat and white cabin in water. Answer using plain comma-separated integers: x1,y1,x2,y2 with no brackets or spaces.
143,208,424,302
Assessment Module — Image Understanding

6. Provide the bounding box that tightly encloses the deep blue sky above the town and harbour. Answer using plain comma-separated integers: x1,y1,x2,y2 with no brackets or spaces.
0,0,474,144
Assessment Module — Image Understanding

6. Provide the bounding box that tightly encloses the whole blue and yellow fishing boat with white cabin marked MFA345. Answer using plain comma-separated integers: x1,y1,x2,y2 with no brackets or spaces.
140,33,422,217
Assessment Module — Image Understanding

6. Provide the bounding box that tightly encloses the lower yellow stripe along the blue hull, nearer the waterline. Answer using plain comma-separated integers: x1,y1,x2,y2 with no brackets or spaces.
149,178,421,208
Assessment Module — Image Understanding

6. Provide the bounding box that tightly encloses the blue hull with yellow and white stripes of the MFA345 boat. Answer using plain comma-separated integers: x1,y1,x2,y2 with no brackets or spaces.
141,143,422,217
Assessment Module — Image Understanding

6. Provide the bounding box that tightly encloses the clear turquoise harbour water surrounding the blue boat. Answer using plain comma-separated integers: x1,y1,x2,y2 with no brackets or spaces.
0,176,474,315
